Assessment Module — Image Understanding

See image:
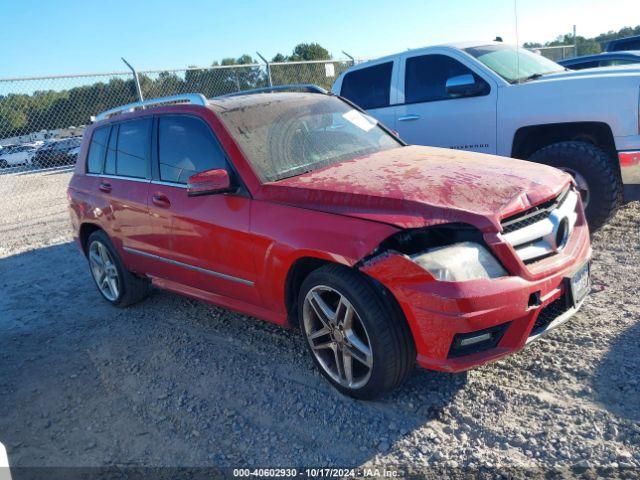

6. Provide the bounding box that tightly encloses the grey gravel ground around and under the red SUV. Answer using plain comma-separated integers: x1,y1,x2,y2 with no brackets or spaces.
0,169,640,477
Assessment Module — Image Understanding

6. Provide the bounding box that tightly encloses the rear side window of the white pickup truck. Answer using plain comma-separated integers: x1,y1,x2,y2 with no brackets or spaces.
340,62,393,110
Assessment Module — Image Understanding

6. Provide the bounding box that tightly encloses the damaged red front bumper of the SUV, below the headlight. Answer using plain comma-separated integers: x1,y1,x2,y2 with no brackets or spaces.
360,229,591,372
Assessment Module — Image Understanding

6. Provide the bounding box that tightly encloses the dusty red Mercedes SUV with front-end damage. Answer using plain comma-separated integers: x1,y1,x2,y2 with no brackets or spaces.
68,87,591,398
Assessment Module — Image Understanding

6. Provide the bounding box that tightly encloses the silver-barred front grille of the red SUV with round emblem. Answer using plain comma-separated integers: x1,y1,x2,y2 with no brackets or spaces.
502,188,579,264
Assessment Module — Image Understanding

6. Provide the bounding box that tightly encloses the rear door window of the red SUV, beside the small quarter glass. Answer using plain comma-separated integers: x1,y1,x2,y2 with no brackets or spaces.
116,118,151,178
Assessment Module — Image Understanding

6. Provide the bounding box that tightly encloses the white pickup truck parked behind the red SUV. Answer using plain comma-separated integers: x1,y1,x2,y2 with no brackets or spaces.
332,42,640,229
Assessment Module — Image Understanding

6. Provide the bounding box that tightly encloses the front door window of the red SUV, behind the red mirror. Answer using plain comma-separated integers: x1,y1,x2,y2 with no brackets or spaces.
158,115,227,183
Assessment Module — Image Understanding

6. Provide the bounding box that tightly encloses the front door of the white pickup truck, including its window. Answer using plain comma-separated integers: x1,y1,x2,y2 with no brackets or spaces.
394,53,498,153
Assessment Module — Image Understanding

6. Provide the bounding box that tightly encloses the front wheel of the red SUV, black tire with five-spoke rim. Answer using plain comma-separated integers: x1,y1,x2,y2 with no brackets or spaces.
298,265,416,400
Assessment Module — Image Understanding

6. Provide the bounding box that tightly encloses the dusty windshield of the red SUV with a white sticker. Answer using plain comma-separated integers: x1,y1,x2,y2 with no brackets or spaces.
210,93,401,182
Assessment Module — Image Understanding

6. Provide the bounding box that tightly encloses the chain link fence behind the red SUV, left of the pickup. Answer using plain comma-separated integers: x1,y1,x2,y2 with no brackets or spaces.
0,60,353,257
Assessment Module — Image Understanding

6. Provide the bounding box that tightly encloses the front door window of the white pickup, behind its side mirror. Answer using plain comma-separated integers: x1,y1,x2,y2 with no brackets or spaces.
404,55,490,103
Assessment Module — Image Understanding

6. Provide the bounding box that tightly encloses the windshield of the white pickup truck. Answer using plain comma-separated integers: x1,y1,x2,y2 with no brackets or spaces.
464,45,565,83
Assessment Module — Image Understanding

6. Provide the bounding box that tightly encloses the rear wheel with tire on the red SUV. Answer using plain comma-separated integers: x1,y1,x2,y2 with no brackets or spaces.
86,230,151,308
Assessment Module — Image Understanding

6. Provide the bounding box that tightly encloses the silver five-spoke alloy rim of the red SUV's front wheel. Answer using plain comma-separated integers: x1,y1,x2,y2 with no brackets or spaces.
302,285,373,389
